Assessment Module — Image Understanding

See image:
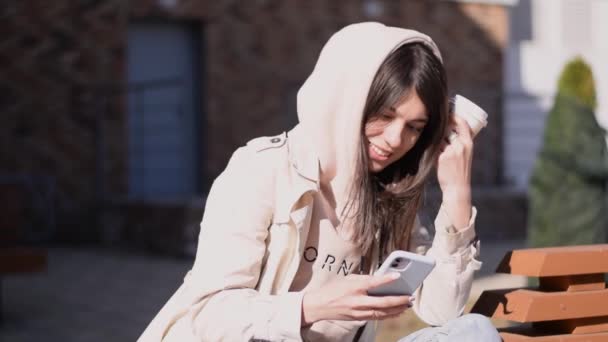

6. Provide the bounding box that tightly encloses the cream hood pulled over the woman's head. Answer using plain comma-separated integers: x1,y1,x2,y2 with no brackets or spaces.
297,22,441,206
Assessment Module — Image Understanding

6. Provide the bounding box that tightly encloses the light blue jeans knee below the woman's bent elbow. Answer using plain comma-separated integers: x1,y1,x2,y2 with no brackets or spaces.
398,314,502,342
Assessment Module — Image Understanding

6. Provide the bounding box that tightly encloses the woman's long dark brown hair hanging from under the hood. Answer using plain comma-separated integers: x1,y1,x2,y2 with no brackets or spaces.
346,43,448,257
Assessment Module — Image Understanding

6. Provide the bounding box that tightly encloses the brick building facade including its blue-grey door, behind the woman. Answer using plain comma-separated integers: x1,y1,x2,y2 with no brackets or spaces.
0,0,509,251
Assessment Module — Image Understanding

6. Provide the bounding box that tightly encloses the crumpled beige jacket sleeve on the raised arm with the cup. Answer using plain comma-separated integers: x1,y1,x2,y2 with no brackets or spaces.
410,207,481,326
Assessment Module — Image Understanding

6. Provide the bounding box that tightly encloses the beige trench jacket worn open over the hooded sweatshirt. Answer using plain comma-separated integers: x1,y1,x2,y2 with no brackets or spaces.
139,128,481,342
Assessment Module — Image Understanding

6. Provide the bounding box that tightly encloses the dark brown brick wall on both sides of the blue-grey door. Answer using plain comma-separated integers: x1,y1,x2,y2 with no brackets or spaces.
0,0,508,240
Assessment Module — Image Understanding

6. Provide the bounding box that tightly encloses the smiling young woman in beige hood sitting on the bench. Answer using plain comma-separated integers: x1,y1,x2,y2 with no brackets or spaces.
140,23,500,341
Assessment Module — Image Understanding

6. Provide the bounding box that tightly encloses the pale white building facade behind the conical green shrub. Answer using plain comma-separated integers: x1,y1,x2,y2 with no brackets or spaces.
504,0,608,187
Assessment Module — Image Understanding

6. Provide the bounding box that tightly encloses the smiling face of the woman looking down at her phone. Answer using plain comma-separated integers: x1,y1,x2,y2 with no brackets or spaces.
365,91,428,173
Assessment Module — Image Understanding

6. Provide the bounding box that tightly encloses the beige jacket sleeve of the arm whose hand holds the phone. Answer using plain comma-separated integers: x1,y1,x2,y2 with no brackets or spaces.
141,147,302,341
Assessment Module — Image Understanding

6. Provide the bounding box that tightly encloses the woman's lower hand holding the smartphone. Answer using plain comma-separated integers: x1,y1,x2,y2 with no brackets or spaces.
302,273,413,326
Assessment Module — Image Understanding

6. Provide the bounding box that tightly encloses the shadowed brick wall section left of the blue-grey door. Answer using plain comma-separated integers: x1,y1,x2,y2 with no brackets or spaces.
0,1,126,207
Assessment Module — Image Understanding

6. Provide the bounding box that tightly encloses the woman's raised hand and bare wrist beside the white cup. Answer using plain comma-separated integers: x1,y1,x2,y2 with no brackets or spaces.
437,115,473,229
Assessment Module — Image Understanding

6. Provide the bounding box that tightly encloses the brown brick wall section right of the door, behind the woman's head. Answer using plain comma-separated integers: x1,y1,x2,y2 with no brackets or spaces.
207,1,508,184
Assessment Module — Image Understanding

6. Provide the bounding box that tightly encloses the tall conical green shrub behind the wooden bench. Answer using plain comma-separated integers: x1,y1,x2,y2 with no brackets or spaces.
528,58,608,246
